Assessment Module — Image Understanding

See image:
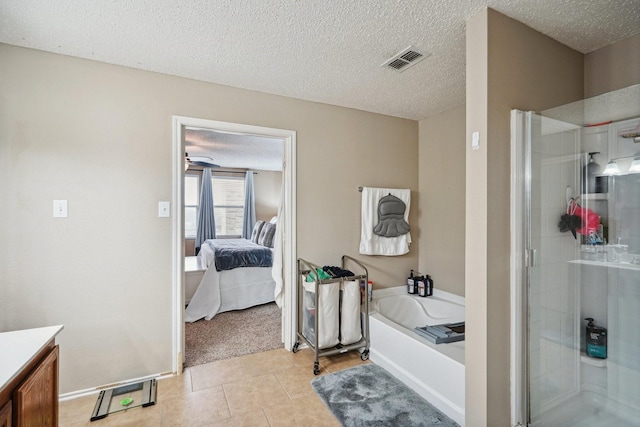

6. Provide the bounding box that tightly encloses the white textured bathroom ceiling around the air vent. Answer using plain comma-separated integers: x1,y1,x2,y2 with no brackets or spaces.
0,0,640,120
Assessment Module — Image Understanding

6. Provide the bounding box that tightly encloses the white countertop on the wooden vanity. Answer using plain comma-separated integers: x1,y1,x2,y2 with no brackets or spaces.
0,325,63,389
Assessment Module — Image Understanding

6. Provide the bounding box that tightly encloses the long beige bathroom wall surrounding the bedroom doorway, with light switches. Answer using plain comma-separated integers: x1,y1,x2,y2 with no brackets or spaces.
0,45,419,393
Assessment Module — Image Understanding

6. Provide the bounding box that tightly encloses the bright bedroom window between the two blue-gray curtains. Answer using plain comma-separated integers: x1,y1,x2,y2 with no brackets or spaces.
212,176,244,238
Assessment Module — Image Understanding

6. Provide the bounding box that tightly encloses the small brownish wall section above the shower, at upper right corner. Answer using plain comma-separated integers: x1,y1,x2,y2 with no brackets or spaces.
584,34,640,98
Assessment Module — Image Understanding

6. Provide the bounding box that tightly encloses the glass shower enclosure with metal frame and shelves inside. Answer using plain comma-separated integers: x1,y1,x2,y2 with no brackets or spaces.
511,85,640,427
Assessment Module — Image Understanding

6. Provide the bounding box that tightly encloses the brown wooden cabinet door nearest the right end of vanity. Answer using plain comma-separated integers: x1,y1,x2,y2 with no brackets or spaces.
13,346,58,427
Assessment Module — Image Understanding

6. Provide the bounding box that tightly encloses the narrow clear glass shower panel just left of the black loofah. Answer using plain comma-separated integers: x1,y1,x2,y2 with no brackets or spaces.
526,113,580,426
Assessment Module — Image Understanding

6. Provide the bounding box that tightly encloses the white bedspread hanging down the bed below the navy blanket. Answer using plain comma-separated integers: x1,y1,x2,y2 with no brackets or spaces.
185,239,276,322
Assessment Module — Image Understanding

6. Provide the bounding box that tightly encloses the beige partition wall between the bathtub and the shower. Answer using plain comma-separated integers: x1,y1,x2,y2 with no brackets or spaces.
465,9,584,426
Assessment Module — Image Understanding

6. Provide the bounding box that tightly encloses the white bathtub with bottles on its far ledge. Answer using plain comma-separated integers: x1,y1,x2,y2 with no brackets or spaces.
369,286,465,426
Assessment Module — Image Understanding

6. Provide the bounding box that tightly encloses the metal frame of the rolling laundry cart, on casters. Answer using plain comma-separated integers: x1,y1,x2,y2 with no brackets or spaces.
293,255,369,375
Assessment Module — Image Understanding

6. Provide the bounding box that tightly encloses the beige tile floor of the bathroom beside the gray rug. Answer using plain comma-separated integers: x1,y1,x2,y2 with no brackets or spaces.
59,349,369,427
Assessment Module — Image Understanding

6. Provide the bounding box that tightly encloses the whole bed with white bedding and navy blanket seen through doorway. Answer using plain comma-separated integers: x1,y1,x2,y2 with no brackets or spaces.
185,223,276,322
